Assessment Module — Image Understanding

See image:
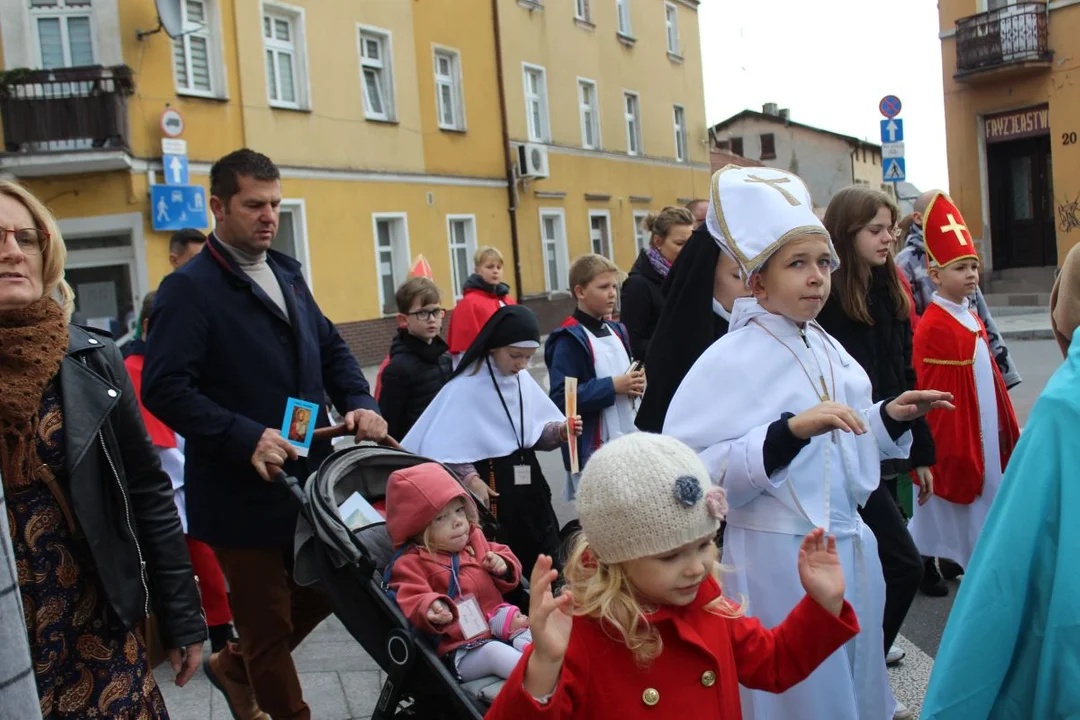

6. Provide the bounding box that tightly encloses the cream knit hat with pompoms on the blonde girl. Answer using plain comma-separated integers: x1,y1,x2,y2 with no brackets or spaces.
578,433,728,565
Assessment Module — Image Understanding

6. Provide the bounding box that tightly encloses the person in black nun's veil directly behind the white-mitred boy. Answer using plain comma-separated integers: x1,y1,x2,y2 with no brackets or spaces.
635,223,750,433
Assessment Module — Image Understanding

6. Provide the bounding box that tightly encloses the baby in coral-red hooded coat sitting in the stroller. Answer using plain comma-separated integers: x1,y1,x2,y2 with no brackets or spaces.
387,463,532,682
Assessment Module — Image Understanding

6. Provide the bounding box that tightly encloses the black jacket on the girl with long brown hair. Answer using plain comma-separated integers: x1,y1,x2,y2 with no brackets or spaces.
818,267,935,473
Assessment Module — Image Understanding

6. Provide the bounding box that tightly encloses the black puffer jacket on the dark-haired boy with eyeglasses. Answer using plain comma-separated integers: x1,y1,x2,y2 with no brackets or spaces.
379,329,454,440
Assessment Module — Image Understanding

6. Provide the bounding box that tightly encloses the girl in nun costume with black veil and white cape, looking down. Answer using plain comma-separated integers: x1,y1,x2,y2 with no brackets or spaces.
402,305,581,575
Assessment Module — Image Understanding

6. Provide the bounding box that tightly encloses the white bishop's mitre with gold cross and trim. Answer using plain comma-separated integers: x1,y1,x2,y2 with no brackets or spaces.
705,165,840,279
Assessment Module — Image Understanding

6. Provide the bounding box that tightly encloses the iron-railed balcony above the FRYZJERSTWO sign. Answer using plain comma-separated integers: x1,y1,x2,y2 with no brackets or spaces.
955,2,1053,81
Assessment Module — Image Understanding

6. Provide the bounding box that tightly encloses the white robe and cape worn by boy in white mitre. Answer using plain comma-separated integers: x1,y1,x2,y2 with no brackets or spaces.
664,298,912,720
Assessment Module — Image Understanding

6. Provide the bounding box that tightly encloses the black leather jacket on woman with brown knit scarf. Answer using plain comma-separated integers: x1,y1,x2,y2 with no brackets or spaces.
58,325,206,648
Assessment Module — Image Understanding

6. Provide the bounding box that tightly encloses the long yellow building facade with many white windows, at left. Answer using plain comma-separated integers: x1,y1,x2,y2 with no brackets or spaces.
0,0,708,362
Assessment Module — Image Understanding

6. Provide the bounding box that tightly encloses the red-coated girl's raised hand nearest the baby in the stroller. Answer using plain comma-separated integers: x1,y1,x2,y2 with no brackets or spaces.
525,555,573,697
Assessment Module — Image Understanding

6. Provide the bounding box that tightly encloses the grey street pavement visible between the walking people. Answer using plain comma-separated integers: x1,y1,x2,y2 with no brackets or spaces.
157,338,1061,720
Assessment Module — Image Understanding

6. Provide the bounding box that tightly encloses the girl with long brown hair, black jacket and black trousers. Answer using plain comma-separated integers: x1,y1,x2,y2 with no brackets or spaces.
818,185,934,718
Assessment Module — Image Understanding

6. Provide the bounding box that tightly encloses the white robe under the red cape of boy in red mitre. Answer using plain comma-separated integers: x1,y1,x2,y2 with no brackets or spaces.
907,294,1002,568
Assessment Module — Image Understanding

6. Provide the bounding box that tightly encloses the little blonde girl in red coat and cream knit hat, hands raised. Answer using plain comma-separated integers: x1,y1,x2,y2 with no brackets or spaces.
486,433,859,720
